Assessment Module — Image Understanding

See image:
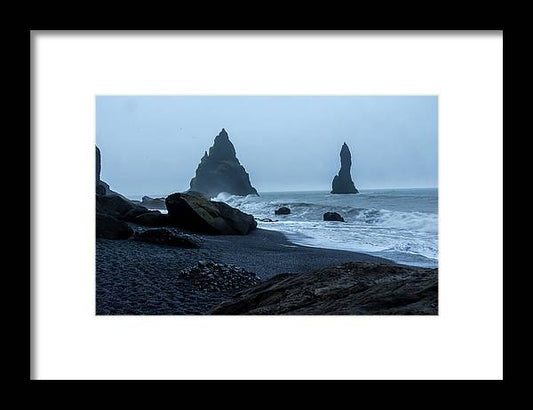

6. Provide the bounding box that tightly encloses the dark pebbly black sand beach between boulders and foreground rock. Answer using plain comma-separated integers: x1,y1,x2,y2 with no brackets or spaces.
96,229,393,315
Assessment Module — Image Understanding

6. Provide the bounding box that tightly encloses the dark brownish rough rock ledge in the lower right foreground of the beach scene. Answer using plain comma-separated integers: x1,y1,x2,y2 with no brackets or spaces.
211,262,438,315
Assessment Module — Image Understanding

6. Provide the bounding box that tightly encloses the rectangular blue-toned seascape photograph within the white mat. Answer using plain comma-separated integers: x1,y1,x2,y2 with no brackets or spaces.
95,95,439,315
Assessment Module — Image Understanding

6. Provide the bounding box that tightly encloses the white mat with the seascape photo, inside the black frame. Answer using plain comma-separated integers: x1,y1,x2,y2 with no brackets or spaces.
31,30,503,380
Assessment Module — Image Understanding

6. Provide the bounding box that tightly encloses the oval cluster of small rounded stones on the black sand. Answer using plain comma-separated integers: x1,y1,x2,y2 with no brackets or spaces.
178,261,261,292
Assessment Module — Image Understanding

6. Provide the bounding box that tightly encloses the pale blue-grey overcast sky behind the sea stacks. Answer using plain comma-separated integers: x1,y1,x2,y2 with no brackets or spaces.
96,96,438,196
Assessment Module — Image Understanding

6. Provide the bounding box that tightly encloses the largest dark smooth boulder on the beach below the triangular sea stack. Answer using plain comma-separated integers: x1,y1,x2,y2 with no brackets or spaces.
166,192,257,235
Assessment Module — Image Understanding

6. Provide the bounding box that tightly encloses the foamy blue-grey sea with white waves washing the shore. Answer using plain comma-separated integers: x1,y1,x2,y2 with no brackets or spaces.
213,188,438,267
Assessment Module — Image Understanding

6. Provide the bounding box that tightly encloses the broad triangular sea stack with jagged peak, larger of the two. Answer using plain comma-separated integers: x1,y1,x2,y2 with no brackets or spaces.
190,128,258,197
